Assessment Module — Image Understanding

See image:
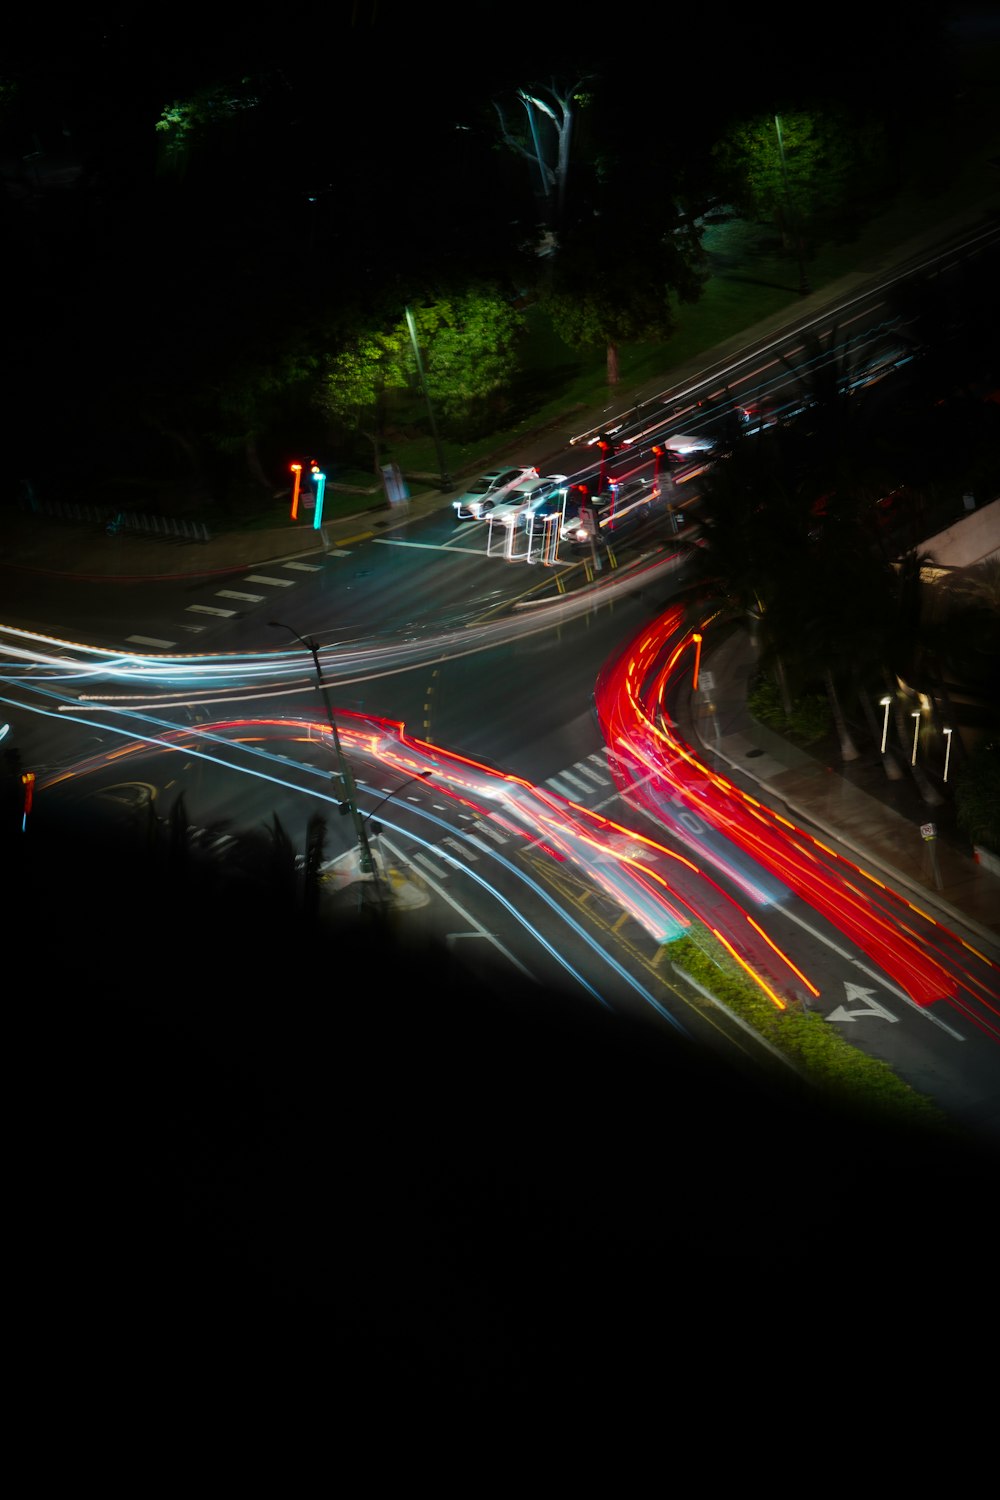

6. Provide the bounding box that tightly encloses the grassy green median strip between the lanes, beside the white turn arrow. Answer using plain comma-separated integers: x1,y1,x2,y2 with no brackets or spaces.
669,924,948,1130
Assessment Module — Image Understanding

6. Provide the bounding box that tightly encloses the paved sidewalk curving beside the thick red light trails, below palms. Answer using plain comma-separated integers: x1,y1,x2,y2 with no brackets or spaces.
691,630,1000,960
